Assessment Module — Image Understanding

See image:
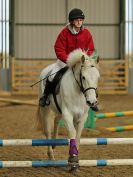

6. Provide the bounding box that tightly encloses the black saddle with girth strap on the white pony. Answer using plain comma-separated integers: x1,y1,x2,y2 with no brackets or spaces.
47,66,68,113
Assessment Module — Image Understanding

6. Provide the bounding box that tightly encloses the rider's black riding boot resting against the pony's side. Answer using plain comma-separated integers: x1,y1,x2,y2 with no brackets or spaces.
39,79,51,107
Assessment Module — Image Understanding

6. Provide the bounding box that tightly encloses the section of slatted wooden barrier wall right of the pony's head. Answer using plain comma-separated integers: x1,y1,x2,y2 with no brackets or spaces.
99,59,128,94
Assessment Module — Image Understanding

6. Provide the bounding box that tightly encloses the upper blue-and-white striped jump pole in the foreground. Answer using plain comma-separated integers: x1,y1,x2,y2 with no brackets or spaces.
0,138,133,146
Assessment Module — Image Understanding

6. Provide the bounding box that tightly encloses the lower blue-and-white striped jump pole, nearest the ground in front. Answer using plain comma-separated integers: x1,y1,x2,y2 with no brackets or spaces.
0,159,133,168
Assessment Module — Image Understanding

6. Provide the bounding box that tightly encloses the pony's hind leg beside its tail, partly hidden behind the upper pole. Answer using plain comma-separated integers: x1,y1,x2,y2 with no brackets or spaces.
41,107,55,160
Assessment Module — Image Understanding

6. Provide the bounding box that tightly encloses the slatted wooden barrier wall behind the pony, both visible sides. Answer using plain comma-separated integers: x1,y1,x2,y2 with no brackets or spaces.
12,59,128,95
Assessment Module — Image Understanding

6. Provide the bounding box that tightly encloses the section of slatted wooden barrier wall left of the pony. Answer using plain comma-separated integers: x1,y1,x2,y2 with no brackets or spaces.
12,59,55,95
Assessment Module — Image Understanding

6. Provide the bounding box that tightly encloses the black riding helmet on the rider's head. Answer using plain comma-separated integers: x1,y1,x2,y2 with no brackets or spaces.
68,8,85,22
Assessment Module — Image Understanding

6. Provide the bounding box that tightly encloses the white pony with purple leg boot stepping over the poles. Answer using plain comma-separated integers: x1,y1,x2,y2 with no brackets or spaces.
37,49,100,171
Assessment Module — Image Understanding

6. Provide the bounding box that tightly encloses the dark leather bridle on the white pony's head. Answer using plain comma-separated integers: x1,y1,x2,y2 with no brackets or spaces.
72,65,98,97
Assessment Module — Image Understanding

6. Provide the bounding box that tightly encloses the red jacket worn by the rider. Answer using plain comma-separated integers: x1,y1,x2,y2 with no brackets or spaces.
54,26,94,63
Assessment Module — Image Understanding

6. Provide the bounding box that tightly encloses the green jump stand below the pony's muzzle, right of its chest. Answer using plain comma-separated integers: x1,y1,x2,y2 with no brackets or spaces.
84,109,95,129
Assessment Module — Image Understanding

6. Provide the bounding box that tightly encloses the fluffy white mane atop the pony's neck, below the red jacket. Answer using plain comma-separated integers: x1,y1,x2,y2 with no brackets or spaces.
67,49,89,67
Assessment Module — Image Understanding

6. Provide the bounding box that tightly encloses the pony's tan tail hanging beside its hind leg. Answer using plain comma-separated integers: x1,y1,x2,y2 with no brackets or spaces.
34,106,44,131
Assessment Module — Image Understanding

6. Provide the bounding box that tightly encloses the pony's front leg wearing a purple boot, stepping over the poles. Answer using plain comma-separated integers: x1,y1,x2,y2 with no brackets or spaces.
63,112,79,171
